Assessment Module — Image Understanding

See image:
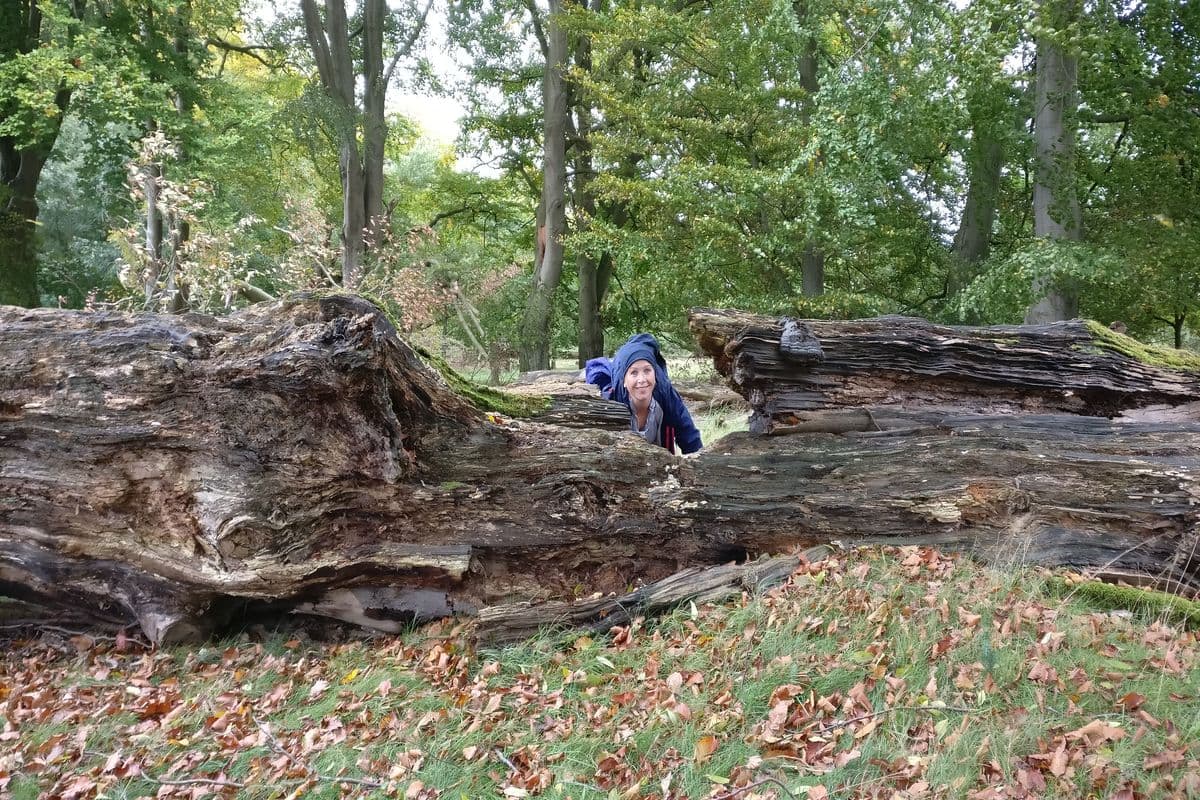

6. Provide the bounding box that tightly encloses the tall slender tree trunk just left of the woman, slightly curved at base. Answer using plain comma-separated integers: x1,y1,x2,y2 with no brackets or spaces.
518,0,568,371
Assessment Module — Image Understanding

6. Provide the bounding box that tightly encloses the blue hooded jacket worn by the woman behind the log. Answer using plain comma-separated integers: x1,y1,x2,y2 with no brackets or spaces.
584,333,703,453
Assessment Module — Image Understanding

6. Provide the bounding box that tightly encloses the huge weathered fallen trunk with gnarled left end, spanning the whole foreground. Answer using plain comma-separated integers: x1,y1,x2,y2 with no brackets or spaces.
0,295,1200,642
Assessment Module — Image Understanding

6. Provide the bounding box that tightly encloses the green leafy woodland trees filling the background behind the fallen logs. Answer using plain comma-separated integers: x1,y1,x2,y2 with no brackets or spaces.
0,0,1200,367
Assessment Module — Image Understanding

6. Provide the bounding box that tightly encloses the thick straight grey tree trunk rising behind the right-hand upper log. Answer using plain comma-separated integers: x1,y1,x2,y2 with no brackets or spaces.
1025,0,1082,324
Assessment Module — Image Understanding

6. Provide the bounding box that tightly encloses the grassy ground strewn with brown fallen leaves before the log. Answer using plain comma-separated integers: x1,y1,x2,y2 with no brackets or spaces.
0,549,1200,800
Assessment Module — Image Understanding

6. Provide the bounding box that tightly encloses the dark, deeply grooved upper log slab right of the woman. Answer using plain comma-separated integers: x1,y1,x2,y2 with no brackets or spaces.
689,308,1200,432
